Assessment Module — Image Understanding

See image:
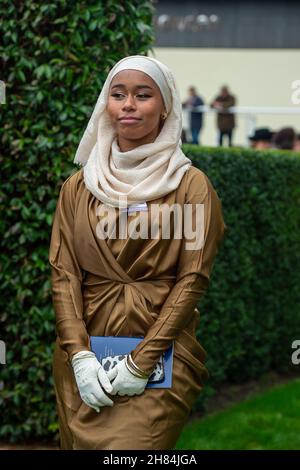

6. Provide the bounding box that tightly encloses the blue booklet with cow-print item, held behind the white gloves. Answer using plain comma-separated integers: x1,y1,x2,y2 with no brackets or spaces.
90,336,174,388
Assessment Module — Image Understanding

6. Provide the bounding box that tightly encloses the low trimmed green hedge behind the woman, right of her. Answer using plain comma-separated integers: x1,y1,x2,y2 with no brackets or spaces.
183,145,300,409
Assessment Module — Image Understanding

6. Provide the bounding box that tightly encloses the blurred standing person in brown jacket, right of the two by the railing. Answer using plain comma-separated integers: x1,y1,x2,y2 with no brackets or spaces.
211,86,236,147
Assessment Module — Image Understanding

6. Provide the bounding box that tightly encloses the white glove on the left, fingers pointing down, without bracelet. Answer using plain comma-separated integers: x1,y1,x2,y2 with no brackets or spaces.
71,351,114,413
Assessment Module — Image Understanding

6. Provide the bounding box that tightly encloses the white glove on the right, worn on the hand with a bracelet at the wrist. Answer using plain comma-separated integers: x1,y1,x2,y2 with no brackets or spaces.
107,358,149,396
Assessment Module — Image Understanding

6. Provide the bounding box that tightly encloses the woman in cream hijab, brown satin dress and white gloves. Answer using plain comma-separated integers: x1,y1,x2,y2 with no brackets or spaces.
49,55,225,450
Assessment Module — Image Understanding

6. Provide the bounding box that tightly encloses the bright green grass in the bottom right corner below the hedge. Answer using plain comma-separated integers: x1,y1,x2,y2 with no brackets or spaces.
176,378,300,450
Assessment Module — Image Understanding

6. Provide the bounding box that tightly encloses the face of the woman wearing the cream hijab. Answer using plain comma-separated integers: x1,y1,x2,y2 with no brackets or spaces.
106,69,165,152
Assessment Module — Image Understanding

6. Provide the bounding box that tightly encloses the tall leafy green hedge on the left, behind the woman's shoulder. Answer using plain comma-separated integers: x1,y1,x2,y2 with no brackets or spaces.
0,0,154,440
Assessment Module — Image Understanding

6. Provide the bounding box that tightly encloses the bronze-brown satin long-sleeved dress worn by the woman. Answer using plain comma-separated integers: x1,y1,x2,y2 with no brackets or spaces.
49,166,226,450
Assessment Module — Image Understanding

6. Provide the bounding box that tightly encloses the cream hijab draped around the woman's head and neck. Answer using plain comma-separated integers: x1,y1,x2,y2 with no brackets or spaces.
74,55,192,207
